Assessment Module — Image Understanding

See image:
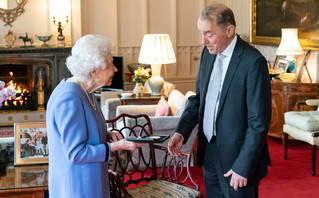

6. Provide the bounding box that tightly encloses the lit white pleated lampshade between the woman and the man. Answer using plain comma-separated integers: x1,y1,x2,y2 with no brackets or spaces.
138,34,176,64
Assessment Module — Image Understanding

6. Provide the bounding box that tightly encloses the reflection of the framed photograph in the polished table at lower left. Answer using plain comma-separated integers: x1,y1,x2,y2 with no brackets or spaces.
15,165,49,188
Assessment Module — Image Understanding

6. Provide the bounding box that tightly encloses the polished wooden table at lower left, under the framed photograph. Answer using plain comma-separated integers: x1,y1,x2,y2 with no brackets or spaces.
0,163,48,198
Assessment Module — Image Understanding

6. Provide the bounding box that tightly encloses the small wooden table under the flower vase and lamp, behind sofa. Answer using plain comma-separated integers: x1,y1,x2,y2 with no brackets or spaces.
118,94,162,105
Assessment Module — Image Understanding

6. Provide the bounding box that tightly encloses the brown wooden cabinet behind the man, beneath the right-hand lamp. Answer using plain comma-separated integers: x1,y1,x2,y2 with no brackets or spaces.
268,80,319,138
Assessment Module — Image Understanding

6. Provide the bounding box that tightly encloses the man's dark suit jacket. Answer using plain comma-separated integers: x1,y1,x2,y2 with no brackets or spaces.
177,36,271,180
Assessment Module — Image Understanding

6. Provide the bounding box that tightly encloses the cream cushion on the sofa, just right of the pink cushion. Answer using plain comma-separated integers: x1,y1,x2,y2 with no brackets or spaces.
168,89,187,116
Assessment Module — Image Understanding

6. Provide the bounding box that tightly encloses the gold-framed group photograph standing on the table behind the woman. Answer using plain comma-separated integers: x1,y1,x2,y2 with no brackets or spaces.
14,122,49,166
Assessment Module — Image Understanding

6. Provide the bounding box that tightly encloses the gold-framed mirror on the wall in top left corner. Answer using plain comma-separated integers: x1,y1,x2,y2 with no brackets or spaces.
0,0,28,27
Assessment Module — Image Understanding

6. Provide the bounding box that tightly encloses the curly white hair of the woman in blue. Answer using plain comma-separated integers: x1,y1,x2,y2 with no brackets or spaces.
66,34,112,80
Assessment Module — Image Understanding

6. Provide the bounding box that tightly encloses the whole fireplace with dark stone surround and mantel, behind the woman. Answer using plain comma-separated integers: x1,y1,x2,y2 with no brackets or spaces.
0,47,71,126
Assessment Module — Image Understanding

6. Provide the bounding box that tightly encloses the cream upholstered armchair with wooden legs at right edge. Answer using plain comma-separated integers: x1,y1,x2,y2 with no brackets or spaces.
282,99,319,176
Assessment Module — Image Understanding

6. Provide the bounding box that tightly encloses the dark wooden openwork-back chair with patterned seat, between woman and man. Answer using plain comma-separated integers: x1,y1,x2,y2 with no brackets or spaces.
106,114,203,197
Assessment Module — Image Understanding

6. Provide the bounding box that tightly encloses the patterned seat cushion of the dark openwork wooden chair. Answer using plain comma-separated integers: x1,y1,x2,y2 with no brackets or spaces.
127,180,200,197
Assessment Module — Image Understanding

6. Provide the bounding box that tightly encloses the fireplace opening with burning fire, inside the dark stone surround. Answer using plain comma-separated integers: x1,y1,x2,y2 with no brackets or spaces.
0,59,51,111
